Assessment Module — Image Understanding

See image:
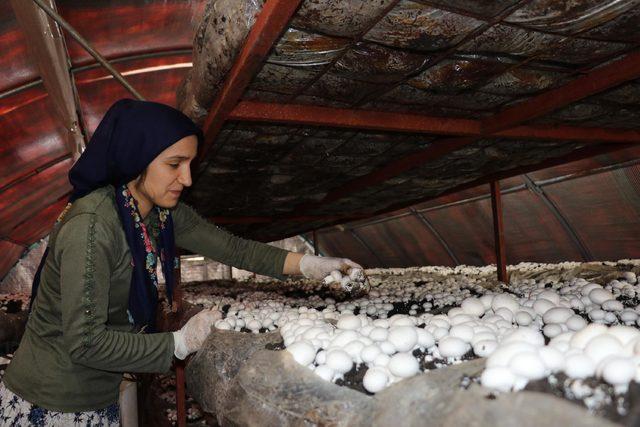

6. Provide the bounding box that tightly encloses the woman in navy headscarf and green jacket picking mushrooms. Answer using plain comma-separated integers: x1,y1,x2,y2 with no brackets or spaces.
0,100,361,425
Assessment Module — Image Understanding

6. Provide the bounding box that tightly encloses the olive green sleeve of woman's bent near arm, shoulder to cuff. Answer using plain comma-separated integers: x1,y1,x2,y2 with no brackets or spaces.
56,214,174,372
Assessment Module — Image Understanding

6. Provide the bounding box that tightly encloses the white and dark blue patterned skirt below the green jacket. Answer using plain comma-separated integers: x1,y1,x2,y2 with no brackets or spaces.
0,381,120,427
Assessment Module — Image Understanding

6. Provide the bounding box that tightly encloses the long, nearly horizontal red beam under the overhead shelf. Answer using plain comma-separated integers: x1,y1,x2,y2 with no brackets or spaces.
229,101,640,143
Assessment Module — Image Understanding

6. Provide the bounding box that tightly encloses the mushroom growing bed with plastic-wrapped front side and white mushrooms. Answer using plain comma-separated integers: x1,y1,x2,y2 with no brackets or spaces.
180,260,640,425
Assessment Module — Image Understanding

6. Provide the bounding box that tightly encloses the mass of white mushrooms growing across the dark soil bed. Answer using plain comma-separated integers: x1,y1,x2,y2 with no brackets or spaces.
181,263,640,393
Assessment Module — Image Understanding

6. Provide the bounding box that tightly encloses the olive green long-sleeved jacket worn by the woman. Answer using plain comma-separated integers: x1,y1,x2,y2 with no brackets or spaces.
3,186,287,412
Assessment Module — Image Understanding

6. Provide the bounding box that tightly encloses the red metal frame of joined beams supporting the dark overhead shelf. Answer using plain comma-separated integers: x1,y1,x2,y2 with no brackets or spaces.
191,0,640,237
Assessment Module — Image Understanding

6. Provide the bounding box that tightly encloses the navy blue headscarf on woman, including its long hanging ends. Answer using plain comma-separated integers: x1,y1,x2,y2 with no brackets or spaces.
32,99,202,331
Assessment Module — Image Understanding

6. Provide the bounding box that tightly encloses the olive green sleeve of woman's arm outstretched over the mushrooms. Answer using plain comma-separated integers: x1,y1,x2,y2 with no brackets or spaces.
172,203,289,279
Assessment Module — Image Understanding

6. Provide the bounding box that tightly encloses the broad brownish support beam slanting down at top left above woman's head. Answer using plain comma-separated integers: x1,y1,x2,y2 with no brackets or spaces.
11,0,86,161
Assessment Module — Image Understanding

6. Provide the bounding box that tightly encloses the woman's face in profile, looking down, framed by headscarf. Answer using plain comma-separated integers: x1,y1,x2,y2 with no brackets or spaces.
129,135,198,211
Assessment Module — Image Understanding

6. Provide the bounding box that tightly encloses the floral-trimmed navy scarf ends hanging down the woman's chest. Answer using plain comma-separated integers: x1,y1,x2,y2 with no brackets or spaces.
116,185,177,332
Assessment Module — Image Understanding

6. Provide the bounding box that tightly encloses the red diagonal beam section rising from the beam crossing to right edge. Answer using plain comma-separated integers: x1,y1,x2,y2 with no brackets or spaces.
482,51,640,134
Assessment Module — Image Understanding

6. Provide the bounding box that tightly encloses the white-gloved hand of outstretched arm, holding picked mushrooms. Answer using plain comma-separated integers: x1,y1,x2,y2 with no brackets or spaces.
300,254,368,292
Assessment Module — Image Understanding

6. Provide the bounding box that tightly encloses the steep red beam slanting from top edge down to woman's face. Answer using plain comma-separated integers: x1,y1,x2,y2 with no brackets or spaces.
200,0,301,159
